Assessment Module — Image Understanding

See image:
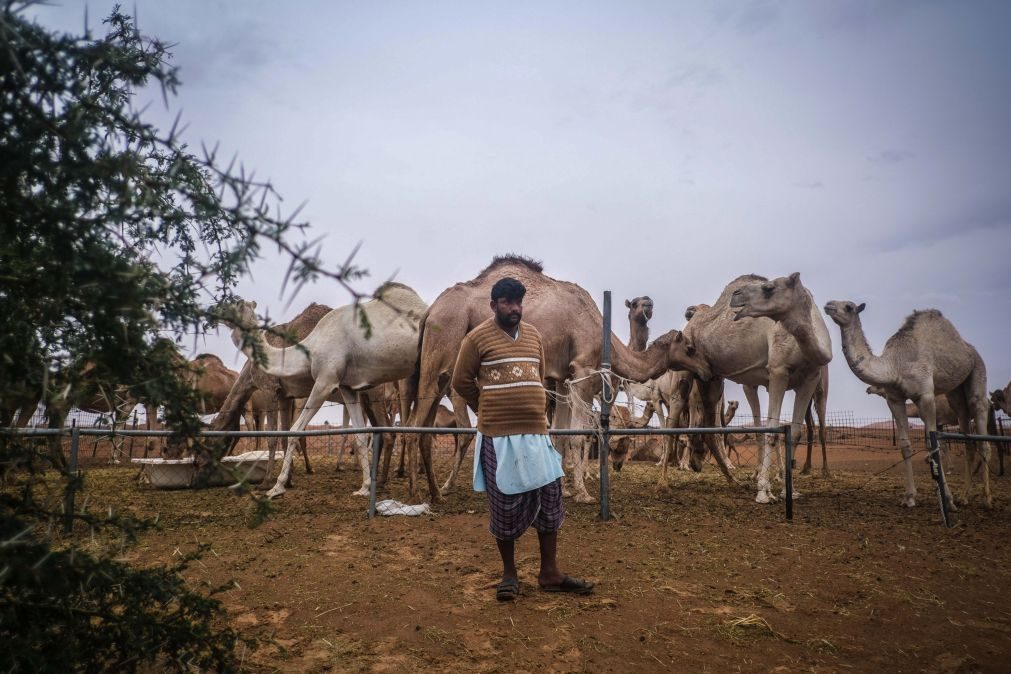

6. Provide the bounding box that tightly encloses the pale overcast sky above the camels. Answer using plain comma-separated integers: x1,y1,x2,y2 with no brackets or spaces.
30,0,1011,417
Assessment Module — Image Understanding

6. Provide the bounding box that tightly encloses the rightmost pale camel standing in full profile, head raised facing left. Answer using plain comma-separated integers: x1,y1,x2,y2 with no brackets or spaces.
825,300,991,507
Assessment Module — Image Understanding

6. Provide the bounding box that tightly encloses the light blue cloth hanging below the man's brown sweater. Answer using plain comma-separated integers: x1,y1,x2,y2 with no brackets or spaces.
474,432,565,494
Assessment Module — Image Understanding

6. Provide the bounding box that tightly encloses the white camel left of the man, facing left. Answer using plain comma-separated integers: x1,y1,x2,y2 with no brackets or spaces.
228,283,428,499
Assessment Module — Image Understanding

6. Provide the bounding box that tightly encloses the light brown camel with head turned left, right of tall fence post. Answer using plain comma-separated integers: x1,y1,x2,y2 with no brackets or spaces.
678,273,832,503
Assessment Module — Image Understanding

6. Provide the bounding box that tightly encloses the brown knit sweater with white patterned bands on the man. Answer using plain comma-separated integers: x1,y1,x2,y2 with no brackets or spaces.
453,317,548,438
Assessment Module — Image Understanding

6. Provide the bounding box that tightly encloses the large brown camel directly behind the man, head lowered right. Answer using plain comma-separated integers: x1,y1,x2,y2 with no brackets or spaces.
410,256,709,503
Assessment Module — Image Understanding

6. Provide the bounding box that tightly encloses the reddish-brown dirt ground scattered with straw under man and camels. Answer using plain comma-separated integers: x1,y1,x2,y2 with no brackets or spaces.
69,440,1011,672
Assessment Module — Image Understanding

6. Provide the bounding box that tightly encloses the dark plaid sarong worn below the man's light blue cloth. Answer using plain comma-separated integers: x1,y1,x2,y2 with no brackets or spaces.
481,436,565,541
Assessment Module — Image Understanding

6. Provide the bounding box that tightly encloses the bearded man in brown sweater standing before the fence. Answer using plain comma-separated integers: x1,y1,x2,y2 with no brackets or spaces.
453,278,593,601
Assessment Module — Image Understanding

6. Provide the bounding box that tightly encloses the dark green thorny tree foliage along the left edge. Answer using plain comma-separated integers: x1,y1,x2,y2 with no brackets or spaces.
0,0,362,670
